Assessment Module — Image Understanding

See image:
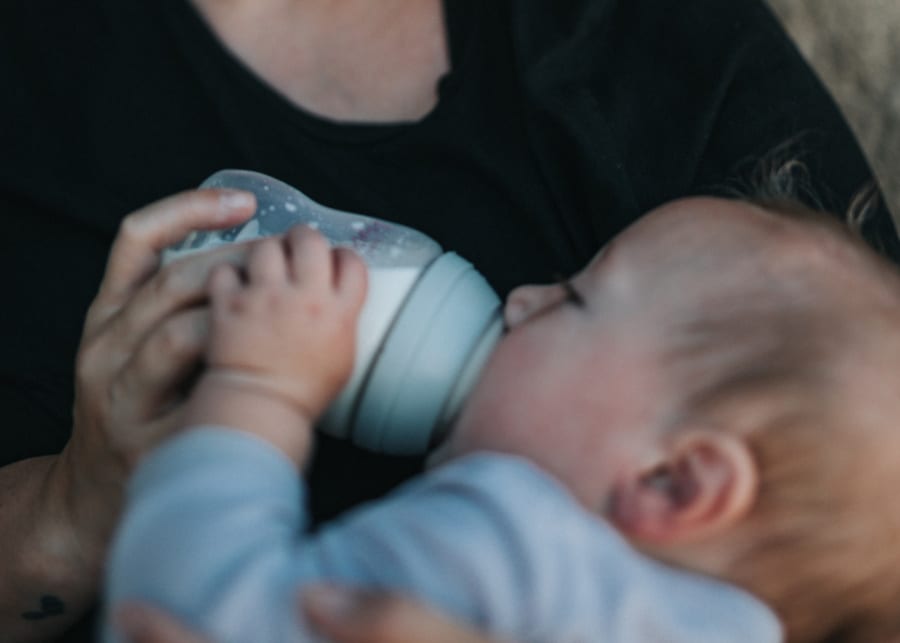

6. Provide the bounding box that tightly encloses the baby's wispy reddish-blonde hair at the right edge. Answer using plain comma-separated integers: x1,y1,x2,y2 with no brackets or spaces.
666,177,900,643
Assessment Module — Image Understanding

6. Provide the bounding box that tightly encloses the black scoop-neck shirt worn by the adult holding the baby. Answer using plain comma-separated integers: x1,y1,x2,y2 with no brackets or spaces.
0,0,900,640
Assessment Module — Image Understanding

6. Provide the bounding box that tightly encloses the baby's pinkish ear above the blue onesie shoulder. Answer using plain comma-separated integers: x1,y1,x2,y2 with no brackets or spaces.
608,430,759,546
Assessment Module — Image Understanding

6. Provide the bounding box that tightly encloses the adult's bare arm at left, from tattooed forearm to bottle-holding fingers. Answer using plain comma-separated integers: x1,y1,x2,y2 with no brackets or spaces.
0,191,253,641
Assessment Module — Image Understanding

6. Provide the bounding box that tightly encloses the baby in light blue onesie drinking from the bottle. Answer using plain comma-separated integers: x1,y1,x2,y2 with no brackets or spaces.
100,192,900,643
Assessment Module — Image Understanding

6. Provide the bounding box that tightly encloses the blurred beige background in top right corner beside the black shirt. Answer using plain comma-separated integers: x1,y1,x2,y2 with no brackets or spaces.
768,0,900,221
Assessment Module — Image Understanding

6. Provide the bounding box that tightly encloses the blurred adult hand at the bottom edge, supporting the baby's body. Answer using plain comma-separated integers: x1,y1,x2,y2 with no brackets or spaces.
116,586,497,643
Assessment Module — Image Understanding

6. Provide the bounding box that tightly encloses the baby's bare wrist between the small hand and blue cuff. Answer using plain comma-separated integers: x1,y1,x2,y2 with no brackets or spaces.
186,370,312,467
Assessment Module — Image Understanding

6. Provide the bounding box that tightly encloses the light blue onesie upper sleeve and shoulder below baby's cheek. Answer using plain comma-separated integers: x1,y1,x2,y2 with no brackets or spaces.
298,453,782,643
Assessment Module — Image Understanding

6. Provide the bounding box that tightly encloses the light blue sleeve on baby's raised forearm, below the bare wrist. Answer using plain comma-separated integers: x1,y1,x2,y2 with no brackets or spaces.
103,427,307,643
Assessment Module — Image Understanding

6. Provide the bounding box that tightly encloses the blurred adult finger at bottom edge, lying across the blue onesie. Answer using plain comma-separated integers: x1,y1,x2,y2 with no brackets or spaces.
302,586,500,643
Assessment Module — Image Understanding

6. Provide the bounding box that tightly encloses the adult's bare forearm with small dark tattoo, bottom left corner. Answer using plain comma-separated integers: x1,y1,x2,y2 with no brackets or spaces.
0,456,108,642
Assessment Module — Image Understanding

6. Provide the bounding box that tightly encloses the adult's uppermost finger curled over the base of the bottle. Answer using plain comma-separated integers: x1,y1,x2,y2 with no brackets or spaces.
98,189,256,298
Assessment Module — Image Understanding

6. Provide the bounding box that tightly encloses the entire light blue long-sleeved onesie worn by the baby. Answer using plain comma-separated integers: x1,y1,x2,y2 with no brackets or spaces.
104,427,782,643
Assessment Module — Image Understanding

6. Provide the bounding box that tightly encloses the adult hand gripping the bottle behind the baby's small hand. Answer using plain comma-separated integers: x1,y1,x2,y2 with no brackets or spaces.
59,190,254,544
